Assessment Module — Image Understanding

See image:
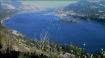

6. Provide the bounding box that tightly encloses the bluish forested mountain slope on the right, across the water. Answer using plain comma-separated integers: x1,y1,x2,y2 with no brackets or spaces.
55,0,105,23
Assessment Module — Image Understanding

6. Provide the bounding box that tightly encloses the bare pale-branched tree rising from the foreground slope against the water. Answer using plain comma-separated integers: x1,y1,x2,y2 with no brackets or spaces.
34,30,50,51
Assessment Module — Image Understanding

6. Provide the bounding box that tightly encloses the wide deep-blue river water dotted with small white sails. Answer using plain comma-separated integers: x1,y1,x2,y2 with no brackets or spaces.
3,11,105,53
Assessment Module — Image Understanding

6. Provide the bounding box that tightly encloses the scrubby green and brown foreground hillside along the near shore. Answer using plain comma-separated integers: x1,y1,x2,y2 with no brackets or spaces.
0,6,105,58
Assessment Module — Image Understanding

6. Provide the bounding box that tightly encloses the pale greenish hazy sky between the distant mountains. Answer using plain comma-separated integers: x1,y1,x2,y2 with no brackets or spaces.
22,1,77,8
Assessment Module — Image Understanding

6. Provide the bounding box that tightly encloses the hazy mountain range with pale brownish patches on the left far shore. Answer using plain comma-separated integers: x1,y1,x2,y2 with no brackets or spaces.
0,1,45,20
